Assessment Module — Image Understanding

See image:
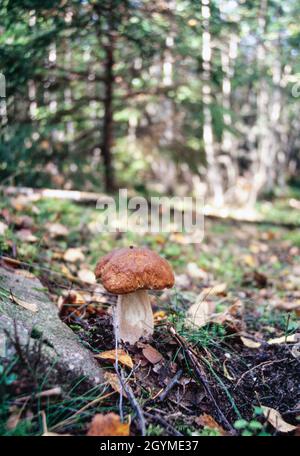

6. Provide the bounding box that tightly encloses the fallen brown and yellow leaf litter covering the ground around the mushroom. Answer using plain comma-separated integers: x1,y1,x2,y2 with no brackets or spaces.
2,199,300,435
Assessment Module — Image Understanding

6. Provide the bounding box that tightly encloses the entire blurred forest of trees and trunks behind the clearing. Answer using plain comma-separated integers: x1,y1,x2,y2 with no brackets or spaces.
0,0,300,206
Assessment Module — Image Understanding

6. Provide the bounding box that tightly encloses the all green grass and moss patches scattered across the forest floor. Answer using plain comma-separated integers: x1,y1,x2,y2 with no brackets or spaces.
0,188,300,436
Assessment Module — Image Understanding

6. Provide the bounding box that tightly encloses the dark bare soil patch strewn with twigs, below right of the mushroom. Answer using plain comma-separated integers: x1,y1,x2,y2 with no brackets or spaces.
68,315,300,435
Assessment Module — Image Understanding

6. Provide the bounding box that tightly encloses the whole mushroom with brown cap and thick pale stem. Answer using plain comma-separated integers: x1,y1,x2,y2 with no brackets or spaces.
95,247,174,344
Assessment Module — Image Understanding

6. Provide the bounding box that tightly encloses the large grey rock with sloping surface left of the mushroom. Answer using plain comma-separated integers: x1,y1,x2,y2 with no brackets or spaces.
0,267,103,386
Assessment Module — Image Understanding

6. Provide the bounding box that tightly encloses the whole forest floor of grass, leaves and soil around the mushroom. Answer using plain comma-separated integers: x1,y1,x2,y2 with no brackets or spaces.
0,191,300,435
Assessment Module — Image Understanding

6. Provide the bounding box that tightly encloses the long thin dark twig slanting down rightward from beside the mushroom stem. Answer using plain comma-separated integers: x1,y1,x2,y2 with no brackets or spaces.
169,326,236,434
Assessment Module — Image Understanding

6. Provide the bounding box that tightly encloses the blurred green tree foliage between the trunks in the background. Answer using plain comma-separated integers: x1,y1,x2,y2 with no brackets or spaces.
0,0,300,192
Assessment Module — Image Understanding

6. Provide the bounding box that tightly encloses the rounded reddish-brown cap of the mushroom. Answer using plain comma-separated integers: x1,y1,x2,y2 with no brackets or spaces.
95,247,174,294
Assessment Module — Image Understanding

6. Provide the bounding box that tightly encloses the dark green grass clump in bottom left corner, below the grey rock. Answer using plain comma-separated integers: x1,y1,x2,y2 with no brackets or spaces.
0,357,118,436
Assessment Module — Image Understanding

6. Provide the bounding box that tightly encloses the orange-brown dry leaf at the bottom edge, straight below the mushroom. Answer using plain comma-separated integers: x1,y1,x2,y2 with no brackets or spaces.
87,413,130,437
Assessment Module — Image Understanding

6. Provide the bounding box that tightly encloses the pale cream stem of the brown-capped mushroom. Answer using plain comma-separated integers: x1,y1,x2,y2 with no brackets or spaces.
114,290,154,344
